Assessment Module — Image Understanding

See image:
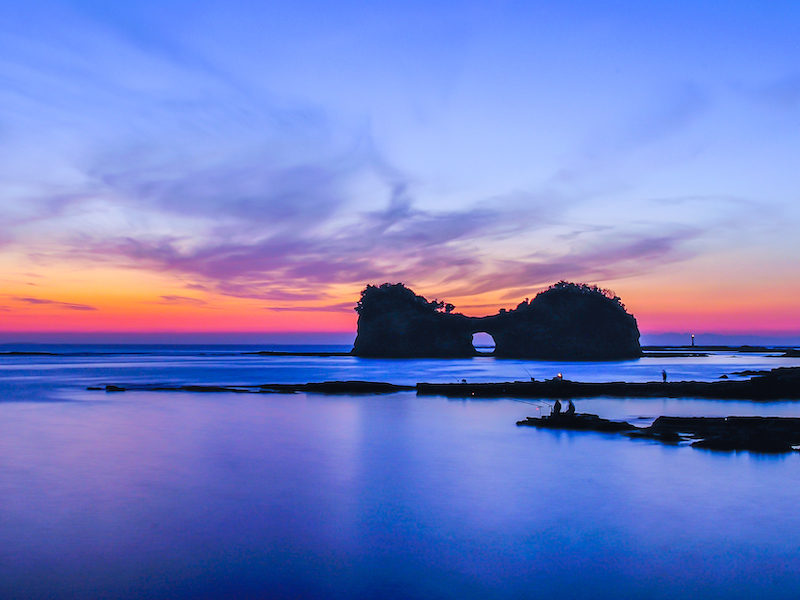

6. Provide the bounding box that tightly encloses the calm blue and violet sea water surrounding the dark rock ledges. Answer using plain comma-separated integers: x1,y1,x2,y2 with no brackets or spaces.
0,346,800,599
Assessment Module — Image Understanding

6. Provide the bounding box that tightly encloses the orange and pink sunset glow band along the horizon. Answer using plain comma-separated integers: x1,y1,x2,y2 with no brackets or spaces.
0,251,800,334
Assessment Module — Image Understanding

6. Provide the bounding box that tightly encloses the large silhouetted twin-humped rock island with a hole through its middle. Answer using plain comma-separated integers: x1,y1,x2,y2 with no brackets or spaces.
352,281,642,360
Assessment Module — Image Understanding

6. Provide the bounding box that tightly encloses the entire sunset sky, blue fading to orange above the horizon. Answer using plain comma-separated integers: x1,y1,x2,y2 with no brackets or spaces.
0,0,800,339
